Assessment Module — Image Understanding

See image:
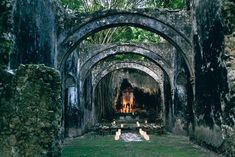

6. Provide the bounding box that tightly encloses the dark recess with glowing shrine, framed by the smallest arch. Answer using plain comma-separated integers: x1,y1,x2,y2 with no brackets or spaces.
93,68,165,122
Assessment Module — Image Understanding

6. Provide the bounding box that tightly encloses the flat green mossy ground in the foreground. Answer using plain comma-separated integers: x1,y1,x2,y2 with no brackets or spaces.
62,134,222,157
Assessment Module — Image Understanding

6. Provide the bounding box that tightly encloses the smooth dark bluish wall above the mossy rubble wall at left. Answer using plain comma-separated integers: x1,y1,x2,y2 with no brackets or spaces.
11,0,57,68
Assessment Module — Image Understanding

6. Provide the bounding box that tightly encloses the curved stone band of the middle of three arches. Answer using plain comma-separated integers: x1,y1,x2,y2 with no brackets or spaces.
80,44,173,85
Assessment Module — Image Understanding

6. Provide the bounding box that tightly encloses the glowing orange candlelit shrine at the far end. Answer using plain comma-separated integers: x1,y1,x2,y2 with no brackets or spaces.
120,89,135,113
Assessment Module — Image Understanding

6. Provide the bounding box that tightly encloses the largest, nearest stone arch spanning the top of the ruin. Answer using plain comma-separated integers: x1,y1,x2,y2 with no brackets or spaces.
57,11,194,77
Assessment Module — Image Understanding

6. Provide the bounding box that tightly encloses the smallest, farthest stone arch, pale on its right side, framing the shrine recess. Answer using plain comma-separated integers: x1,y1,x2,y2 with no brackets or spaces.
80,60,167,128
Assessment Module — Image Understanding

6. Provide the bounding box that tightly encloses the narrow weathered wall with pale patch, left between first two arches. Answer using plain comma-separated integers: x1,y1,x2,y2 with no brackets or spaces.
62,52,83,137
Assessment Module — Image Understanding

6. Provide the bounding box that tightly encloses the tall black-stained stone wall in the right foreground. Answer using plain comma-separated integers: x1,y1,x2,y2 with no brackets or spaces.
191,0,235,156
